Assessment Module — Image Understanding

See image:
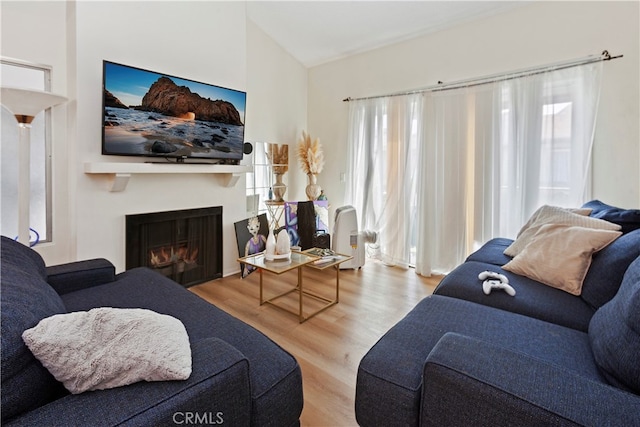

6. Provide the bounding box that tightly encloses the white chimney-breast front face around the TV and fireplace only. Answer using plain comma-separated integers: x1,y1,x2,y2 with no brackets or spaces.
74,2,247,274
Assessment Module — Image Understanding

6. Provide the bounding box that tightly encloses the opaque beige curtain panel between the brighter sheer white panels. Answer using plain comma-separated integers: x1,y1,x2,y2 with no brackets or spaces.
416,89,484,275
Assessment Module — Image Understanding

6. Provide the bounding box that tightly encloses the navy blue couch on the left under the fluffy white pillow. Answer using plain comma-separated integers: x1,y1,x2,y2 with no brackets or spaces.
0,237,303,427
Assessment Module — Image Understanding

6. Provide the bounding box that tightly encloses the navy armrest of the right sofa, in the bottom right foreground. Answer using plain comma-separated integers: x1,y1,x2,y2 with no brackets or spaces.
420,333,640,426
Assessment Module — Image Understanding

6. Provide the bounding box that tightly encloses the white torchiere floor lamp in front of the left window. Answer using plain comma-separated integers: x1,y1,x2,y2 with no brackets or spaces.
0,87,67,246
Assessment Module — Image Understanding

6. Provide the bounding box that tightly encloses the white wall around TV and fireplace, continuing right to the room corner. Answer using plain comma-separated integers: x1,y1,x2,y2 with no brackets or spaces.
72,2,306,275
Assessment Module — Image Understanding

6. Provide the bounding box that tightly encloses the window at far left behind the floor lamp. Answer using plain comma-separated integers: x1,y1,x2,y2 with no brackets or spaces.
0,59,51,244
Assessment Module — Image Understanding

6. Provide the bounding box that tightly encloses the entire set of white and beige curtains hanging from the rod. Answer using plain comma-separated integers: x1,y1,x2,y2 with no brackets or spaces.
346,62,602,275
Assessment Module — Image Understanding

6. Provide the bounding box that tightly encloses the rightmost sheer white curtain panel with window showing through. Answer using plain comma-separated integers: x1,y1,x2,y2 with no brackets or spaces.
493,62,602,237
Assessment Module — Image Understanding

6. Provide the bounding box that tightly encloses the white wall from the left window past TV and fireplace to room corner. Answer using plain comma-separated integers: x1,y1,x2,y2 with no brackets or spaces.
2,1,306,275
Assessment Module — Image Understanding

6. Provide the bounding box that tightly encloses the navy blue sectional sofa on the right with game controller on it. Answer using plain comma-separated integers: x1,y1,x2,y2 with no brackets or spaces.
355,201,640,426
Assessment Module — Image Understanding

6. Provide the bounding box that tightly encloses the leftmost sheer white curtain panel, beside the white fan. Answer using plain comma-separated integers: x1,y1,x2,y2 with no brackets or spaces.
346,95,422,266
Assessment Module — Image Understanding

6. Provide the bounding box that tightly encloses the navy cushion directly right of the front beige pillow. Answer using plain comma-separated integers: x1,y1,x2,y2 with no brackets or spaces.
580,229,640,310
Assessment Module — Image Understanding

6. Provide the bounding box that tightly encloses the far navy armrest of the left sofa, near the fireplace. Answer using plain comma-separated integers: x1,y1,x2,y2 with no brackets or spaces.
47,258,116,295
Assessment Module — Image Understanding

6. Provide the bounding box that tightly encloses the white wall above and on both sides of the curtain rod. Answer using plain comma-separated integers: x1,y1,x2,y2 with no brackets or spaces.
308,1,640,217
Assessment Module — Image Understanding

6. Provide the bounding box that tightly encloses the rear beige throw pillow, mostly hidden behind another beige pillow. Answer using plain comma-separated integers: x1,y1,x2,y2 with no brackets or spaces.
504,205,620,257
